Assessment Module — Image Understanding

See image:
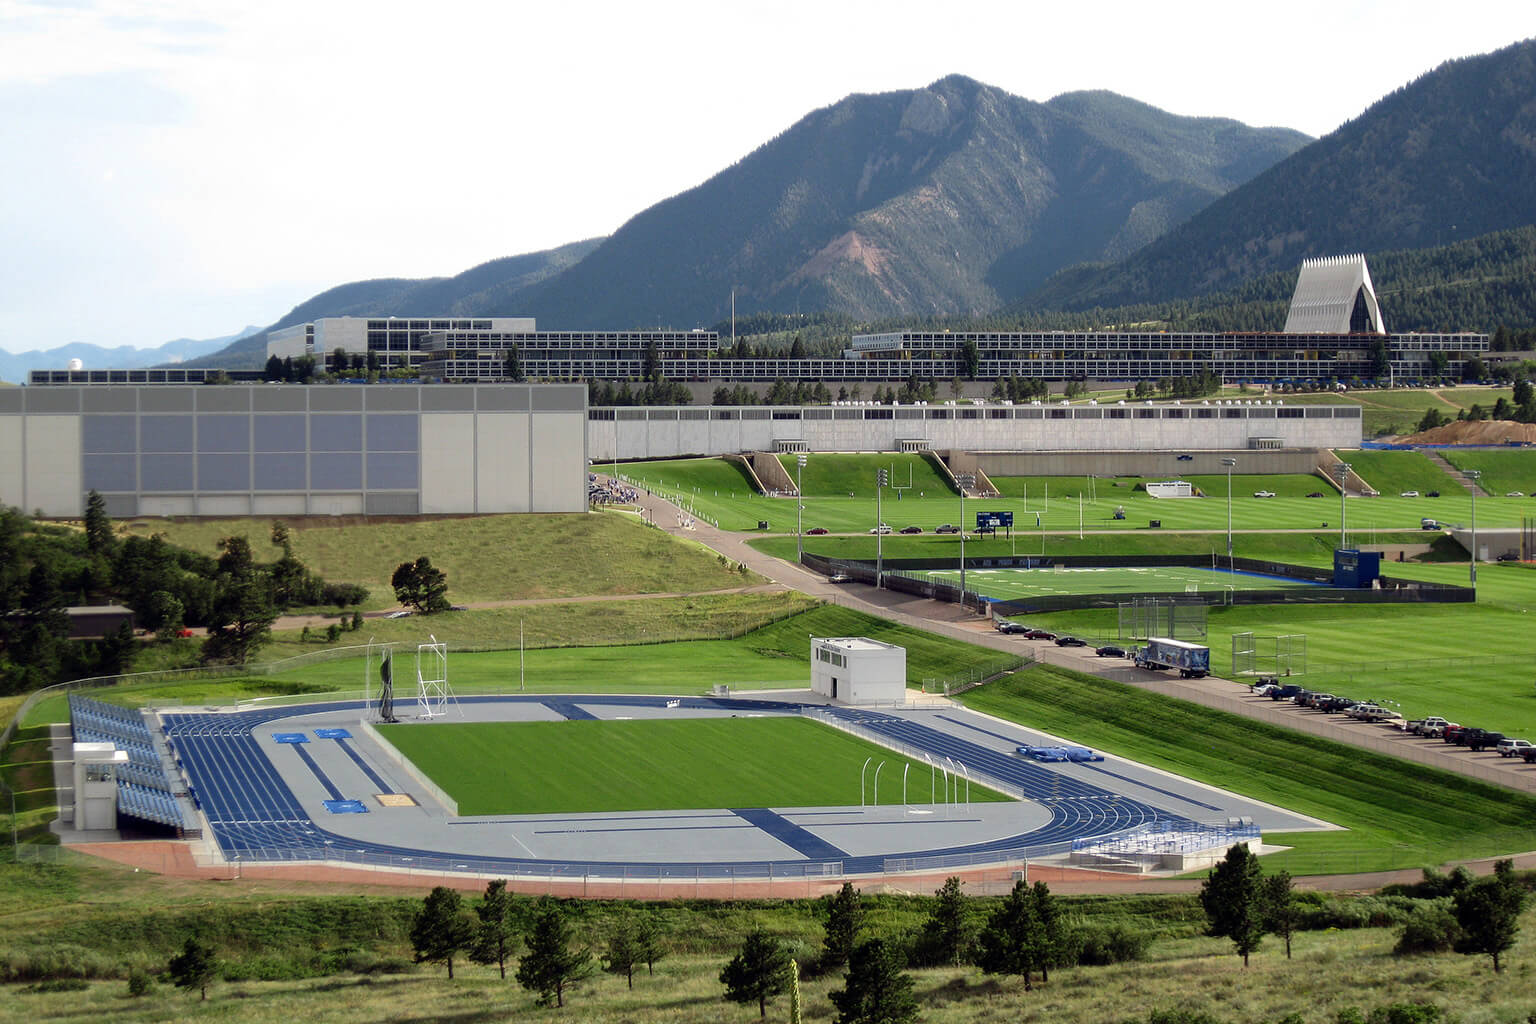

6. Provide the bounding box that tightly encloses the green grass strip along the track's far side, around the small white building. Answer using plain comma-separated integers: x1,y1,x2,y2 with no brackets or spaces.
14,605,1018,725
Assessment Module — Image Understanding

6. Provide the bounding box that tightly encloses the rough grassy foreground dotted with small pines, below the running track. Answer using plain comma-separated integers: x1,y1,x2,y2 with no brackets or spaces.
0,866,1536,1024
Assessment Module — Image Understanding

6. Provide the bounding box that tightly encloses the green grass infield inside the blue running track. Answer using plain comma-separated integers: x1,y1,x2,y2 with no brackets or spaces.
379,717,1006,815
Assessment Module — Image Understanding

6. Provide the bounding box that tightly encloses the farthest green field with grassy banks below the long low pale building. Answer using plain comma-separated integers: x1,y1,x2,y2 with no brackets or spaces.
619,451,1536,537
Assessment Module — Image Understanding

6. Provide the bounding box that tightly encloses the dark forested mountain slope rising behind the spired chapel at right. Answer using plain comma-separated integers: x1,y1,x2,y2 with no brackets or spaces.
1025,40,1536,310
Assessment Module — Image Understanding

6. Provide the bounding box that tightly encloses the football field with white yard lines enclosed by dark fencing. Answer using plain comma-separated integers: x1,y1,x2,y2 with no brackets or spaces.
905,565,1318,600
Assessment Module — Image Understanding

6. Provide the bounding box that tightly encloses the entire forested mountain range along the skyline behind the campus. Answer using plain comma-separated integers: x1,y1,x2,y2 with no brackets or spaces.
197,40,1536,367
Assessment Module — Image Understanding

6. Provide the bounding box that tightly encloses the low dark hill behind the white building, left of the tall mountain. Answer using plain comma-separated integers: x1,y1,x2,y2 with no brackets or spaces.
184,238,602,370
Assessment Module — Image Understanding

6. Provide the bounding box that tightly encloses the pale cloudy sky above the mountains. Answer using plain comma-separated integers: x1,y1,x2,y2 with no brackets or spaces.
0,0,1536,352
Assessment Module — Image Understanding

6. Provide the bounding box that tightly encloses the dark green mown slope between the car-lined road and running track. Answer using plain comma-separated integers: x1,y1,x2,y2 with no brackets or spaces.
962,665,1536,875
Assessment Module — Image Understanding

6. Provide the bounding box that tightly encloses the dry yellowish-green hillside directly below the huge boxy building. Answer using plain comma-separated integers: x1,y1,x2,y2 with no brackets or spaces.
123,511,762,608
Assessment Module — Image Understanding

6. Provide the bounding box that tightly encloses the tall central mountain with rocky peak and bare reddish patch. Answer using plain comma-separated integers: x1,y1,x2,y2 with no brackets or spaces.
519,75,1307,329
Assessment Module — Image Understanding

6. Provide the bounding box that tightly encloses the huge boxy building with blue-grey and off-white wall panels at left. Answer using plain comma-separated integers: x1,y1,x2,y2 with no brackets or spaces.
0,384,587,517
